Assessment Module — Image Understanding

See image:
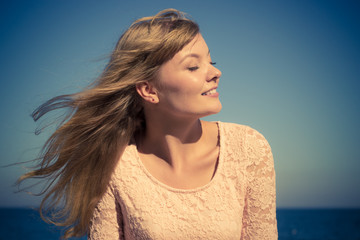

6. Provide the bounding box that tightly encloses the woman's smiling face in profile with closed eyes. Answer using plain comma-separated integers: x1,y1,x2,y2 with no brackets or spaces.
157,34,221,118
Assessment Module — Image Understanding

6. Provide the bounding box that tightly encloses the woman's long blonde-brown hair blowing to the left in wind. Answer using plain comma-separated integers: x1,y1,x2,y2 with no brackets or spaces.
18,9,199,238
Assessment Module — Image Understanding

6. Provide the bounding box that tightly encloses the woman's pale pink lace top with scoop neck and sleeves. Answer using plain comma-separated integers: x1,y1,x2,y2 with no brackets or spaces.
89,122,277,240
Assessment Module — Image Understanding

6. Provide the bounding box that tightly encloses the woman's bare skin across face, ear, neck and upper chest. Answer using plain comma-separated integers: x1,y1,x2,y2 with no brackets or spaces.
136,34,221,189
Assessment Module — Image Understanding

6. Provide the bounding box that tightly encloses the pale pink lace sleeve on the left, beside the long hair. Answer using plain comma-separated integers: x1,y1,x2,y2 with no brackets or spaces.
88,183,124,240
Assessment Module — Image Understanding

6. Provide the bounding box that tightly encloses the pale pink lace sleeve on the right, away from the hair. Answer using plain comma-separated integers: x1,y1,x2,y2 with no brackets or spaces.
241,128,278,240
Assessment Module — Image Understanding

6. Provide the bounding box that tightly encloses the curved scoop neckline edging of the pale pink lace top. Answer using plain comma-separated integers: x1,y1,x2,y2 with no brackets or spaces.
131,121,224,193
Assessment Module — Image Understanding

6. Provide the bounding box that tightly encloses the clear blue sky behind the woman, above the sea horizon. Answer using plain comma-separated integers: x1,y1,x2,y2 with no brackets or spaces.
0,0,360,207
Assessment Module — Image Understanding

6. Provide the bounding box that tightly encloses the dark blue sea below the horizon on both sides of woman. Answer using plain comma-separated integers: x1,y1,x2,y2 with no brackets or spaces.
0,208,360,240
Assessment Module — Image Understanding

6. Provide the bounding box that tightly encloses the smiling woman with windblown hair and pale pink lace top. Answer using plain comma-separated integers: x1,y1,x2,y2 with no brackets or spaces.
20,9,277,239
